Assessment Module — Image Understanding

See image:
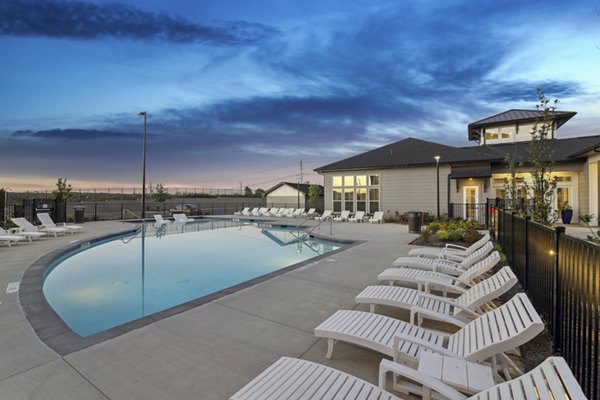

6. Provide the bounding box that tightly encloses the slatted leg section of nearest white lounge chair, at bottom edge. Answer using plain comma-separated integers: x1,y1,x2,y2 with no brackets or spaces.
230,357,399,400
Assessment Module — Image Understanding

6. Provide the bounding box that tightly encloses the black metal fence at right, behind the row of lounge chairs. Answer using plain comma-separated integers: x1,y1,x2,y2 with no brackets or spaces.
488,202,600,399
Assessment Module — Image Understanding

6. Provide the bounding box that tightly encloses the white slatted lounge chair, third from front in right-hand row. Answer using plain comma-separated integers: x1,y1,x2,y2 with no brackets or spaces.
354,267,518,327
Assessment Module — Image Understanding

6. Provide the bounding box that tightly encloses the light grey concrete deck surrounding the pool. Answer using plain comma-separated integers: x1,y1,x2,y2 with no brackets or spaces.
0,220,442,400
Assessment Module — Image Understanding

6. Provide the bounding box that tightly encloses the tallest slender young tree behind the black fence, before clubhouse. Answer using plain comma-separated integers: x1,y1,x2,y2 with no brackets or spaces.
525,88,558,225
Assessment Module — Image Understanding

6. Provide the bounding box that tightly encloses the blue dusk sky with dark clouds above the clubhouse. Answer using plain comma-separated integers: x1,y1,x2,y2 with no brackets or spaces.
0,0,600,191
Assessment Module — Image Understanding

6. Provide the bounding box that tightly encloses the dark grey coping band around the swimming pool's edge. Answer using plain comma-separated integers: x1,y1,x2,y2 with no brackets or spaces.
19,219,365,356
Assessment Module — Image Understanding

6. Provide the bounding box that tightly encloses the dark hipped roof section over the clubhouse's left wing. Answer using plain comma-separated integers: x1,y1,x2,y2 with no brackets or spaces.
315,138,481,172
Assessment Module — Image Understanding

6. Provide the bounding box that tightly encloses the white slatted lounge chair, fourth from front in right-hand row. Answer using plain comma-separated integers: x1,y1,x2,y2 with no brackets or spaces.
377,251,500,296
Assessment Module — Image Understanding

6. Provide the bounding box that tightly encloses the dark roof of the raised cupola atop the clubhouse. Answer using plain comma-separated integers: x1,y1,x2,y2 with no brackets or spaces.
467,109,577,140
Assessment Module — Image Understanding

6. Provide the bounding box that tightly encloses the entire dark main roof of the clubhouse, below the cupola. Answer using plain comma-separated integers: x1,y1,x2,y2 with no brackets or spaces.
312,135,600,173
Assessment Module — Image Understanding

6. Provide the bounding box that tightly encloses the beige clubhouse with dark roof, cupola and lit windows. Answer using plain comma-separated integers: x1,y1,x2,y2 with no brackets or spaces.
315,110,600,222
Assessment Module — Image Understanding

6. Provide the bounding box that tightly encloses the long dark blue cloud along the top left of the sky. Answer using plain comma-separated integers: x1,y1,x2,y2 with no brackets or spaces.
0,0,278,45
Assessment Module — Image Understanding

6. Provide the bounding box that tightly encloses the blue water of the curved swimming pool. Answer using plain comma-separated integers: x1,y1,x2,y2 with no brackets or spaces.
43,220,344,337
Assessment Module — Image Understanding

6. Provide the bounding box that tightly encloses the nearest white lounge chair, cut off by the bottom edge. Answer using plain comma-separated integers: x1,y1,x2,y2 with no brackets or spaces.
230,357,586,400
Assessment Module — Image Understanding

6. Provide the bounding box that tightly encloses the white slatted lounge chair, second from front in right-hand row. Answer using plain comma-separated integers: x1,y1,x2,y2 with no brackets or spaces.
315,293,544,373
